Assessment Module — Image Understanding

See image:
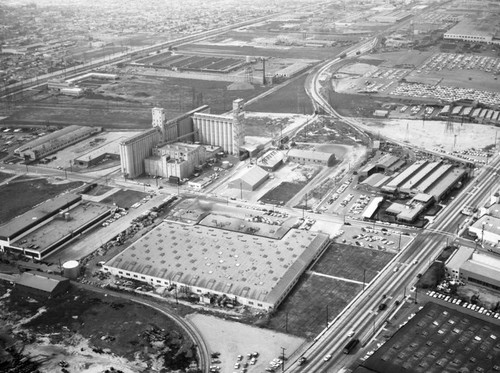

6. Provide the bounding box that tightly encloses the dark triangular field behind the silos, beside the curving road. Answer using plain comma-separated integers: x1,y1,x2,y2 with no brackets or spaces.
245,75,313,114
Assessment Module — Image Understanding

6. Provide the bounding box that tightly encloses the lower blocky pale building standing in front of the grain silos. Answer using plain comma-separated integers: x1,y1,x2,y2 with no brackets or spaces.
144,143,206,179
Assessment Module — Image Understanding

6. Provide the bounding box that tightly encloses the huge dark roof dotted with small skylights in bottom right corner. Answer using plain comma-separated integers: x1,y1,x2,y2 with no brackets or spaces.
354,302,500,373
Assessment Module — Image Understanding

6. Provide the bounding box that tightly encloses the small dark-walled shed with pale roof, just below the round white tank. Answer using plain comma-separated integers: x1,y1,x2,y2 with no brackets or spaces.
15,271,70,298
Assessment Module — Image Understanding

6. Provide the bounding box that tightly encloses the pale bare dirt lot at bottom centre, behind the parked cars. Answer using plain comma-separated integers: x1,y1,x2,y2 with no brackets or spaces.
188,314,304,373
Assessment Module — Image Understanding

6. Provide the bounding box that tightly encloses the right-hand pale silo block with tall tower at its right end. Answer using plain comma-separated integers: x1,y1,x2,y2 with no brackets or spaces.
193,99,245,156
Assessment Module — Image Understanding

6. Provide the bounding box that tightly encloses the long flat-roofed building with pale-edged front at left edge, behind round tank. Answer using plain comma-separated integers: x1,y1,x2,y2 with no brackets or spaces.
0,193,111,260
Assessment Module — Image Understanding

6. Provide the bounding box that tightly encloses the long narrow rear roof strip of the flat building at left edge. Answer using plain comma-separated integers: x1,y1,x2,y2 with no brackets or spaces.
0,193,82,240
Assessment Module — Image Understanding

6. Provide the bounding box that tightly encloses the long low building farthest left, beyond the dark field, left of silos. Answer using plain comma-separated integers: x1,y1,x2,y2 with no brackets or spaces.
14,125,102,160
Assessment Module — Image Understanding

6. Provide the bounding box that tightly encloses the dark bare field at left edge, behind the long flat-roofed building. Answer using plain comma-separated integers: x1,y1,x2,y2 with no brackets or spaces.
0,179,83,224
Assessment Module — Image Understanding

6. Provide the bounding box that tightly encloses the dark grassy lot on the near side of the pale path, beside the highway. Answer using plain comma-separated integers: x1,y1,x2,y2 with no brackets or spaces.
267,273,363,338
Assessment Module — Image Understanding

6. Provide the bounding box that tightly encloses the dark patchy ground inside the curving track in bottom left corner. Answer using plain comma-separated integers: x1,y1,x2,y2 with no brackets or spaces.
0,283,199,373
